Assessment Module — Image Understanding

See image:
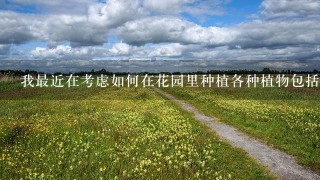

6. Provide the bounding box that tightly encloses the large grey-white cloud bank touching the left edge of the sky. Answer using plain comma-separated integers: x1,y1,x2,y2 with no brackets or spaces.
0,12,108,46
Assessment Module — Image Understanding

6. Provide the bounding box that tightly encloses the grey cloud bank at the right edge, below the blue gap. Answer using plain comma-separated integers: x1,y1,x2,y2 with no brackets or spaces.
230,19,320,48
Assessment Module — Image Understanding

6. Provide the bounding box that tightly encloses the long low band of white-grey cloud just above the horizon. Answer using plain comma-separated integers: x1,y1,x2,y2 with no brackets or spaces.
20,40,320,60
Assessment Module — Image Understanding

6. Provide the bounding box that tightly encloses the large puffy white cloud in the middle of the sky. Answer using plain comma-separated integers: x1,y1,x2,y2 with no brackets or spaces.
118,17,237,46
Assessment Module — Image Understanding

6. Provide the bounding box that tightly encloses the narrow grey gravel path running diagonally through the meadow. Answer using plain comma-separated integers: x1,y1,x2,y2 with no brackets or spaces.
154,88,320,180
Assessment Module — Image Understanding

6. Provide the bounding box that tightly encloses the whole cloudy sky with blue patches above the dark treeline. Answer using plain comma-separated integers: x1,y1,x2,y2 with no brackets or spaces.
0,0,320,60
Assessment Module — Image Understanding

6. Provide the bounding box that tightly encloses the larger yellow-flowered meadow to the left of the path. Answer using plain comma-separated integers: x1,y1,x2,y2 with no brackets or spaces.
0,88,276,179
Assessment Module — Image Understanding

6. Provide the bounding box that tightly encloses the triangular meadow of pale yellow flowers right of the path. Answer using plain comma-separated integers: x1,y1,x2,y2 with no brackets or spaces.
164,88,320,173
